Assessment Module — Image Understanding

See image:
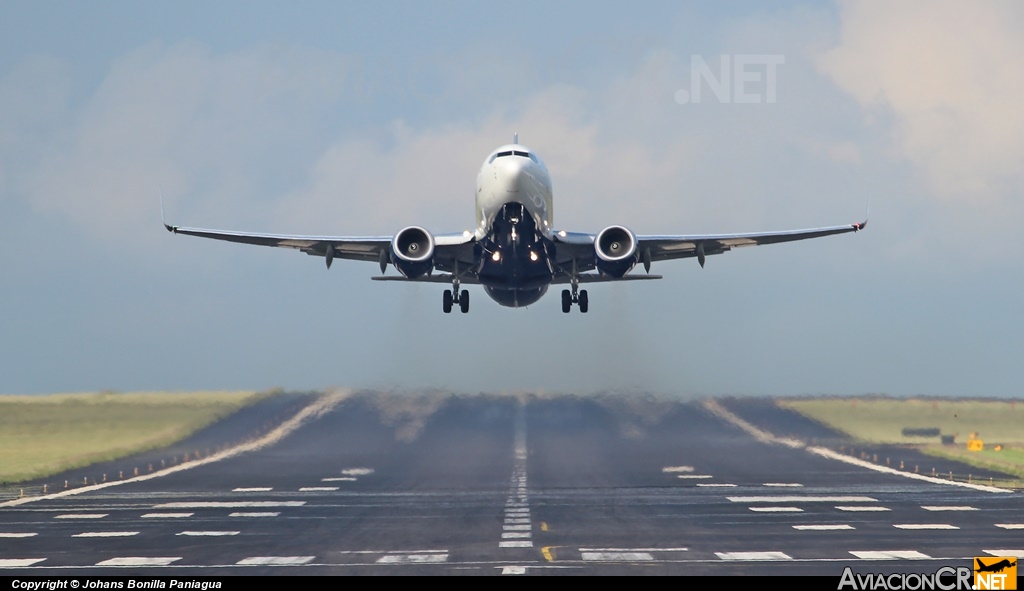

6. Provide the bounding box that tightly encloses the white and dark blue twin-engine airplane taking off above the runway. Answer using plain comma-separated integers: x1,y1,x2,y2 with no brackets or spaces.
161,133,867,313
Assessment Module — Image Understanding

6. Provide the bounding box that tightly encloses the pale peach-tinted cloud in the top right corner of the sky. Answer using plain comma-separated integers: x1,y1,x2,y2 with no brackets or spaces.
820,0,1024,199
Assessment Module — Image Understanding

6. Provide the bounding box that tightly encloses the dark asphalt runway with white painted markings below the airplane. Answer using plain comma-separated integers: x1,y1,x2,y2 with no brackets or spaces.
0,392,1024,578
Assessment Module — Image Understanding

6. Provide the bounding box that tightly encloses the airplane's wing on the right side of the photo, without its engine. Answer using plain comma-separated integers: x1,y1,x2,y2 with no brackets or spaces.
555,220,867,270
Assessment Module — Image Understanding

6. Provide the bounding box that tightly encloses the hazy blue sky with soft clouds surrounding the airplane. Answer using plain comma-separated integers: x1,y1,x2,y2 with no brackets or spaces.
0,2,1024,395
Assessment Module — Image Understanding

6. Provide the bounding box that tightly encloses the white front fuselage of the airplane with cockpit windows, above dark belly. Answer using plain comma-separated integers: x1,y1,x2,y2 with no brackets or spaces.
476,143,554,239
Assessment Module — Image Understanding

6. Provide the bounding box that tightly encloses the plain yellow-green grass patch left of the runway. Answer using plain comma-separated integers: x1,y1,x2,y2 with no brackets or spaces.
0,391,269,483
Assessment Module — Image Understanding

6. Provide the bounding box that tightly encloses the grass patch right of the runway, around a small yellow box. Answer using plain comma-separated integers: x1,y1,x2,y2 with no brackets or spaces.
777,397,1024,478
